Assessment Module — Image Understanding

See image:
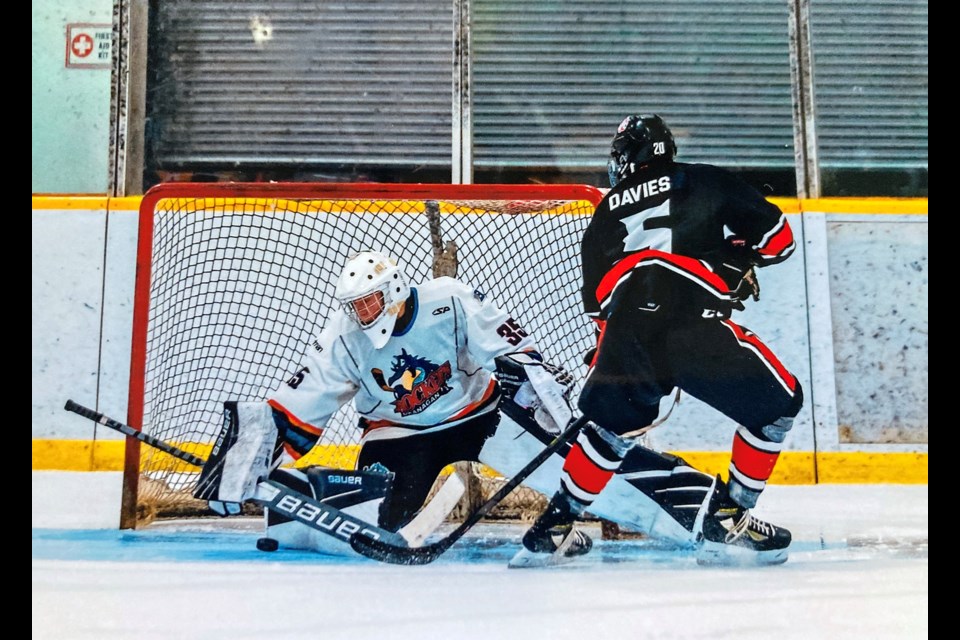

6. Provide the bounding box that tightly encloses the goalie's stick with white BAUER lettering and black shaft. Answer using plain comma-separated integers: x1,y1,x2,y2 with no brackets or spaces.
63,400,463,547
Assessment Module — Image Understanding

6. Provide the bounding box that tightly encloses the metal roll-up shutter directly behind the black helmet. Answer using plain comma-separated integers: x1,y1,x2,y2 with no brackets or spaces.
471,0,794,174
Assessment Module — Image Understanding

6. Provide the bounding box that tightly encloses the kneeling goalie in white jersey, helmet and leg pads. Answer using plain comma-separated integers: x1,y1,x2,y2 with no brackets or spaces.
194,251,736,554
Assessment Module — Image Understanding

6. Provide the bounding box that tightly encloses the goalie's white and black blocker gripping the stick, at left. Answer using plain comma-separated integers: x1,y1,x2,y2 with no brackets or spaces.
193,401,283,516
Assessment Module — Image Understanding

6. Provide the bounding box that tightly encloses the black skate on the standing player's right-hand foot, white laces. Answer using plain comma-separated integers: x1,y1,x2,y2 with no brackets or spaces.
697,476,792,565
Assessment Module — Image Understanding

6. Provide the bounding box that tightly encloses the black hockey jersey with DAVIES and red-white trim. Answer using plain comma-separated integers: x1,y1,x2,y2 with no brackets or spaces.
581,162,796,321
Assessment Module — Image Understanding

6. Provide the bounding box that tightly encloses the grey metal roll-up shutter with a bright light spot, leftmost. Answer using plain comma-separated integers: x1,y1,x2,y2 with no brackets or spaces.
147,0,453,172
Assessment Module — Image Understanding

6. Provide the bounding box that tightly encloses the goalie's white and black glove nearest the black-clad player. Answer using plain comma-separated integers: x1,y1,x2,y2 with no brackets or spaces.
494,351,574,433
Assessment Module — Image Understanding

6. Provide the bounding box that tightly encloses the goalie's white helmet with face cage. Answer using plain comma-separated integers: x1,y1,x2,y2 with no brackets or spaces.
334,251,410,349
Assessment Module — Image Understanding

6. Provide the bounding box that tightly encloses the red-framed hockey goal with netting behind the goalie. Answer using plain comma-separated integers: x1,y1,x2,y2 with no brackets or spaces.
120,182,603,529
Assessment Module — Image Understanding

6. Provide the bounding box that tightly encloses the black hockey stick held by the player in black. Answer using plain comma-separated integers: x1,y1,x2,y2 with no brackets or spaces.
350,416,587,564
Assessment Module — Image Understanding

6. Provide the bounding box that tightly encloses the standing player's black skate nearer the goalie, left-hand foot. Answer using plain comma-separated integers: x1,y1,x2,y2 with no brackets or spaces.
507,492,593,569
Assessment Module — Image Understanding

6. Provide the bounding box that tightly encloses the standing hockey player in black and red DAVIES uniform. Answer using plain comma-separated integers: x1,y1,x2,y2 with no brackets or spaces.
511,115,803,566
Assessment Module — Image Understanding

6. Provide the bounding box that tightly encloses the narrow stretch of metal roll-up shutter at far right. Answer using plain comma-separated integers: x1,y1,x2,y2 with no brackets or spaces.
810,0,928,169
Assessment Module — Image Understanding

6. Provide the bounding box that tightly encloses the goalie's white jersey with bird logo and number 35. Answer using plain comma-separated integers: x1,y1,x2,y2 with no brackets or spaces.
268,277,537,439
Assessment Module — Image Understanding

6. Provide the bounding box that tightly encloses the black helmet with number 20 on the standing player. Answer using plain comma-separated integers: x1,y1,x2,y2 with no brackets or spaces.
607,115,677,187
